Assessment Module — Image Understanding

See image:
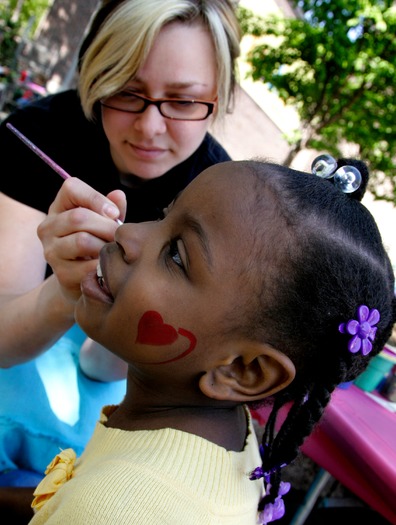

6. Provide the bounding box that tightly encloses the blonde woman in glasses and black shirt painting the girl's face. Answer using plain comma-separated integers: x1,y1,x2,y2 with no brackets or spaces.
0,0,240,485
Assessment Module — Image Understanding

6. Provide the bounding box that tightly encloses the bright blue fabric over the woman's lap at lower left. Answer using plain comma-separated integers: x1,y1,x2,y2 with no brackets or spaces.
0,325,126,485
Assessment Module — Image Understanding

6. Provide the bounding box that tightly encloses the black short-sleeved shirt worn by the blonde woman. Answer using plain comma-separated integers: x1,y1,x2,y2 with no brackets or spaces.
0,90,230,222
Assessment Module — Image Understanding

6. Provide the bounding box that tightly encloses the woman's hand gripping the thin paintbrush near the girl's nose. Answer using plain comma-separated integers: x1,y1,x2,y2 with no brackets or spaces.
37,177,126,303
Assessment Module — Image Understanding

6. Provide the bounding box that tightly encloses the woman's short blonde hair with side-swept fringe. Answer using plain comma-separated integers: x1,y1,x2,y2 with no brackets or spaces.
78,0,241,120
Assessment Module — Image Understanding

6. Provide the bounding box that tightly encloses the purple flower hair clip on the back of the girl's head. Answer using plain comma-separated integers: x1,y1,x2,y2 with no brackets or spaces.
338,304,380,355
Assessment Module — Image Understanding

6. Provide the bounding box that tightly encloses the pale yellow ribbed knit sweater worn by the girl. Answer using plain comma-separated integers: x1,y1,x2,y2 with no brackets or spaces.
30,407,263,525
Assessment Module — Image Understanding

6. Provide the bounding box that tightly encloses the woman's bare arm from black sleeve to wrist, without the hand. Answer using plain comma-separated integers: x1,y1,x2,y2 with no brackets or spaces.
0,190,74,367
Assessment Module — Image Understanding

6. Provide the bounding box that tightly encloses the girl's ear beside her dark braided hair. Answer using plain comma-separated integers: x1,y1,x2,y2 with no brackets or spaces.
199,341,296,403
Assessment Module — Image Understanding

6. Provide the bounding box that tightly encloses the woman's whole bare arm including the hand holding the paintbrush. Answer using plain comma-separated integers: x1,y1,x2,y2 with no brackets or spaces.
0,178,126,367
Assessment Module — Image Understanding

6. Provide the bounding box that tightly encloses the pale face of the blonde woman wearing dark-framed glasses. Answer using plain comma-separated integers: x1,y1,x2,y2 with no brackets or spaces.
102,23,217,183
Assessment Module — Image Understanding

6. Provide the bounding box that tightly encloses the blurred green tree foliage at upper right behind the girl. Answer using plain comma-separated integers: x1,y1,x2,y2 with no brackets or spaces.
238,0,396,204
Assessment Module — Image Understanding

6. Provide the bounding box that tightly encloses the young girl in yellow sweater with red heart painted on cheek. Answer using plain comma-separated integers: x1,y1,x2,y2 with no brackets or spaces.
31,157,396,525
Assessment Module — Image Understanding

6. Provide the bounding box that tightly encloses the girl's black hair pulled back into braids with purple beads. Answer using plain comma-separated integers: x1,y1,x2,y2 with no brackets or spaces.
245,159,396,523
